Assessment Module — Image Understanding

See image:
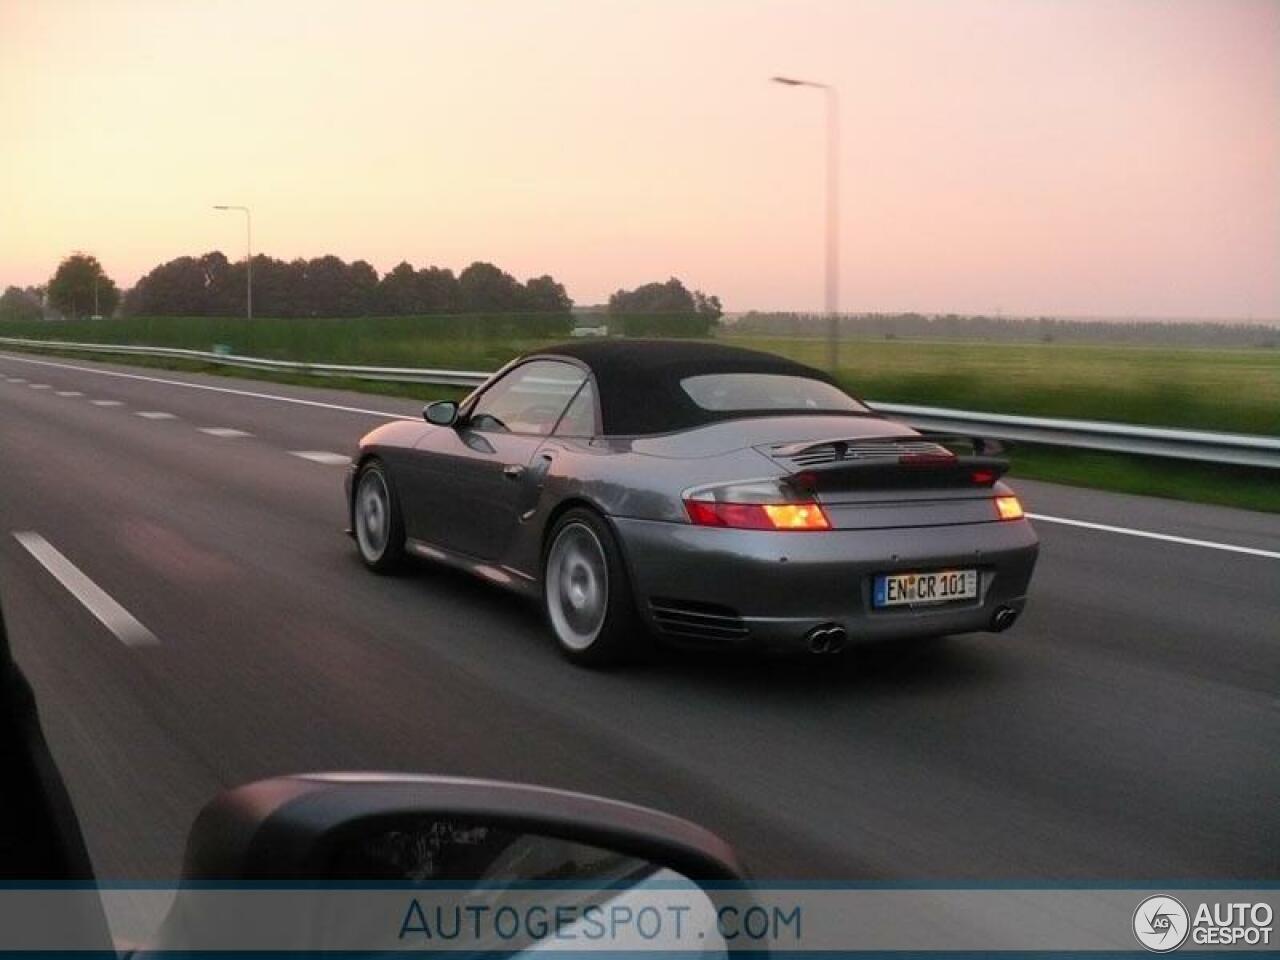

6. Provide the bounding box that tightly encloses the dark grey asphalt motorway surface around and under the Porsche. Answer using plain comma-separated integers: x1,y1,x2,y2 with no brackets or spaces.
0,355,1280,882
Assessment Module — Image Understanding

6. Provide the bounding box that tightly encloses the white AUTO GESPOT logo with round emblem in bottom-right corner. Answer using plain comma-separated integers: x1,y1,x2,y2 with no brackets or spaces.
1133,893,1275,954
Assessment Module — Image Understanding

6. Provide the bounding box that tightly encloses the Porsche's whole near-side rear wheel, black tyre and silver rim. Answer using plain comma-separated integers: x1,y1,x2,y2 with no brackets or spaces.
541,507,643,667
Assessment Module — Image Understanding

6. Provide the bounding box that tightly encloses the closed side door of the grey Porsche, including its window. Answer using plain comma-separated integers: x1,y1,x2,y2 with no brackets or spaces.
408,360,586,561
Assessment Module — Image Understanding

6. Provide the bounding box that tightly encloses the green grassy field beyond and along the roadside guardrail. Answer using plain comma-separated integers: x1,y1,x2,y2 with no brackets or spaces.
0,317,1280,511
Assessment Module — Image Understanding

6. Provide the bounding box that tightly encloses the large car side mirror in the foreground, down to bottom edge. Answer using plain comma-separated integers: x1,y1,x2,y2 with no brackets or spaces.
156,773,759,955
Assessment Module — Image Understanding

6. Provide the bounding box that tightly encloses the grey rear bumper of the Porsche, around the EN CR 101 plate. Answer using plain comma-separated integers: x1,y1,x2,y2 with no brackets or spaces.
613,517,1039,650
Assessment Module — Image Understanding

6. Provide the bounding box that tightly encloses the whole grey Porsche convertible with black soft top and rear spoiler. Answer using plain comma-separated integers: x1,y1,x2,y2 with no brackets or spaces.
347,340,1037,664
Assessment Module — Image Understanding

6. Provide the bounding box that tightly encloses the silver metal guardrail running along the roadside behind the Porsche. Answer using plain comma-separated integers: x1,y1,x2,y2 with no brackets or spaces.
0,337,1280,470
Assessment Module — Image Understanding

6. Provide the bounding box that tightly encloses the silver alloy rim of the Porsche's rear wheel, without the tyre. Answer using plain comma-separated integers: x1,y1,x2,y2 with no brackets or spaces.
543,521,609,650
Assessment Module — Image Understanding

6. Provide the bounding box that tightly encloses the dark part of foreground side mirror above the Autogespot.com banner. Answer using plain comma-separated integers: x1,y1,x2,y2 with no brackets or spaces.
175,773,744,882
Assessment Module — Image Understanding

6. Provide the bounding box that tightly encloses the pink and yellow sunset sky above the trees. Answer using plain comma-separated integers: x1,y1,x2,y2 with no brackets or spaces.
0,0,1280,319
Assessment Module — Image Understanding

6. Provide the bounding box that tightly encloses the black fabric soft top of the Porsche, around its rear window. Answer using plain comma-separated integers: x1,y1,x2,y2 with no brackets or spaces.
536,340,835,436
